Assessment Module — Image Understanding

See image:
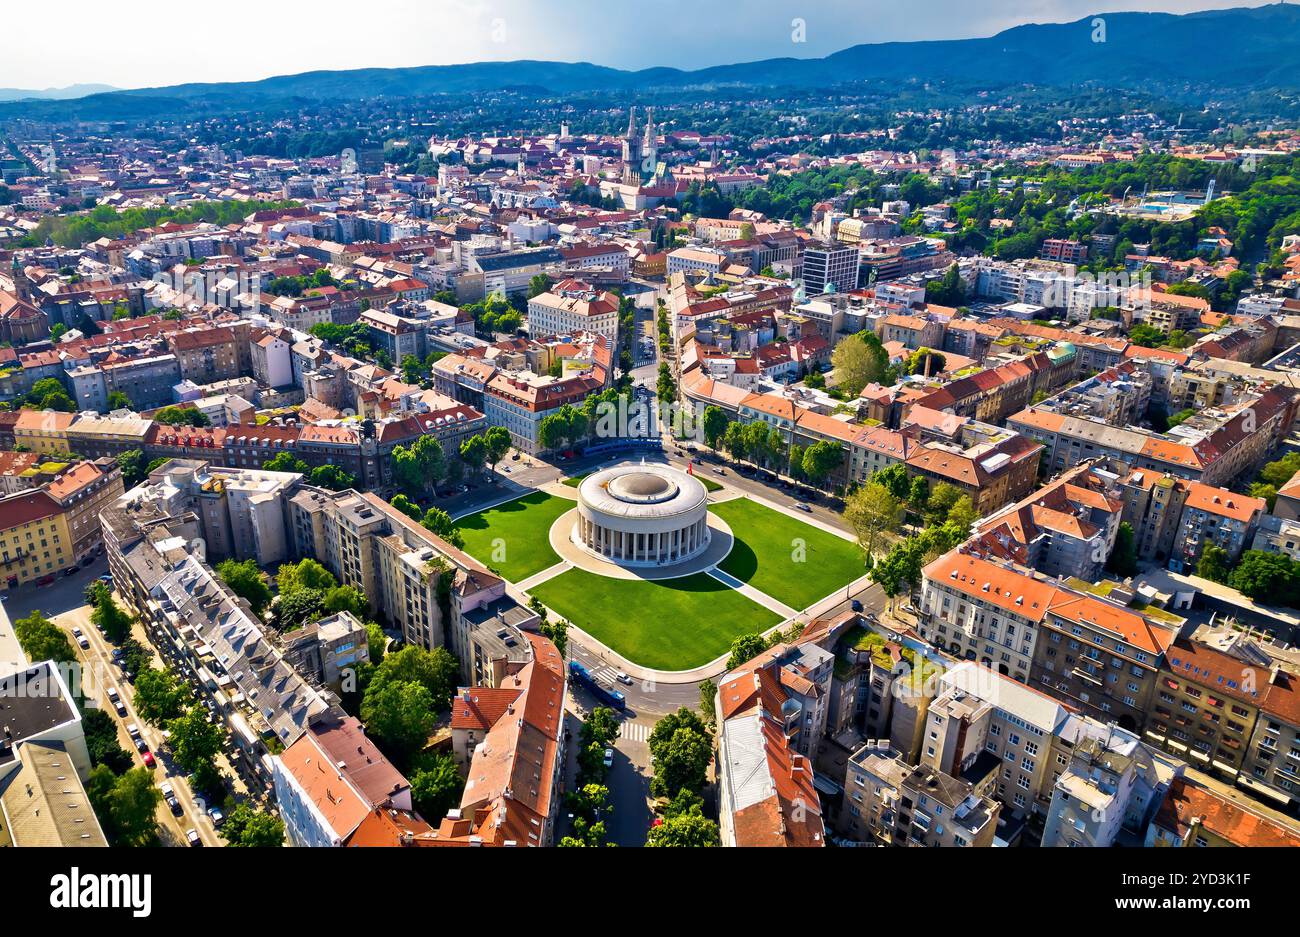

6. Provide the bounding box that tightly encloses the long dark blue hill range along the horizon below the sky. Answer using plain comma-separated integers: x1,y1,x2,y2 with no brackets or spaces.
0,4,1300,120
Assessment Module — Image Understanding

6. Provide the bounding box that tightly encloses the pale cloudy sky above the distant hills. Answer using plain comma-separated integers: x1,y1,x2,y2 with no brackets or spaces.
0,0,1279,90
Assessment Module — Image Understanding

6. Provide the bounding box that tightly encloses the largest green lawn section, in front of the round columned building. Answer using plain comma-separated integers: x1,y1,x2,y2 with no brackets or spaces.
530,569,781,671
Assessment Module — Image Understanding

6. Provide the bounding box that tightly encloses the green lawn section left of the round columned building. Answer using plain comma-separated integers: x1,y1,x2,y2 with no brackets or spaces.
456,491,575,582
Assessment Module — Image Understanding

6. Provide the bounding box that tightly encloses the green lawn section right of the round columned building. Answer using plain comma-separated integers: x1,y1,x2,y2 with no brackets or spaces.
712,498,866,610
